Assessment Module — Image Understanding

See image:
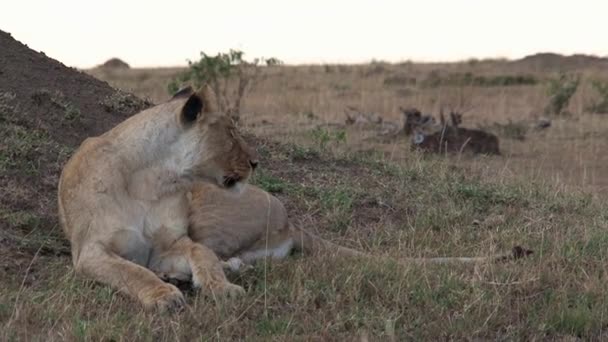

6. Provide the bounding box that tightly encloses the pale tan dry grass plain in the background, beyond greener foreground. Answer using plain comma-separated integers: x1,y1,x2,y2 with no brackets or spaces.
88,54,608,195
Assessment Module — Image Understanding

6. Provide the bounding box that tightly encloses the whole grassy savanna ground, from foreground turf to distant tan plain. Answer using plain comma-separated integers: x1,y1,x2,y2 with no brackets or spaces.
0,39,608,341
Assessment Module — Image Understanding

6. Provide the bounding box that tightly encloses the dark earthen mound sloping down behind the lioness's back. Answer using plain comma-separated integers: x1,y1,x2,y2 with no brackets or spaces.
0,31,151,268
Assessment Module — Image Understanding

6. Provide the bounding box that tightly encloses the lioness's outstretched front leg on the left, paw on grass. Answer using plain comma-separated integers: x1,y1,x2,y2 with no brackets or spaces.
75,243,186,311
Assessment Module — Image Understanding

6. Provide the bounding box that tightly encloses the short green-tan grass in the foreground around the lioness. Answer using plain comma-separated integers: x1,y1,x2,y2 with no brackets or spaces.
0,142,608,341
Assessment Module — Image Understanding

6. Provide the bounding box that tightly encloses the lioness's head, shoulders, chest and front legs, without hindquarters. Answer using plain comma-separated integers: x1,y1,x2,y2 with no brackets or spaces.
58,87,258,310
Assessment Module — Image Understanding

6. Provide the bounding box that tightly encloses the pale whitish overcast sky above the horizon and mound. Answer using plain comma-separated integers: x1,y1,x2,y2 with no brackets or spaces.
0,0,608,68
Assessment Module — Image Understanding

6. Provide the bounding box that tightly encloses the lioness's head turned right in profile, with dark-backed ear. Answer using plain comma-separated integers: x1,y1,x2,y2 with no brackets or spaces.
173,86,258,189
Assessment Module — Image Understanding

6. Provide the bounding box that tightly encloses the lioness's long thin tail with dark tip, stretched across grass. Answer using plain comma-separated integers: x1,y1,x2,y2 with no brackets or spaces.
290,225,533,264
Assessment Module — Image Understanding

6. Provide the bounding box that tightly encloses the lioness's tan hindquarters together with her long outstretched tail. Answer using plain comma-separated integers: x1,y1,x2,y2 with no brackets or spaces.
184,183,531,280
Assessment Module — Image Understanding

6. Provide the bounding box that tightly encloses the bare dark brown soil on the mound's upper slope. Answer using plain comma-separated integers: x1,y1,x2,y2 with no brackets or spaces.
0,31,150,145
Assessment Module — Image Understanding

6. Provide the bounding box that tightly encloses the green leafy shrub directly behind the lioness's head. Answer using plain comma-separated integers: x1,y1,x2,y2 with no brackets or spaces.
167,49,282,120
